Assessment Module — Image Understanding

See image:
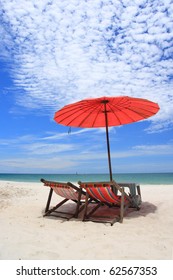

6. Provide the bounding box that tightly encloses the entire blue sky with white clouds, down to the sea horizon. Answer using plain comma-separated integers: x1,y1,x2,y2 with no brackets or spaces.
0,0,173,173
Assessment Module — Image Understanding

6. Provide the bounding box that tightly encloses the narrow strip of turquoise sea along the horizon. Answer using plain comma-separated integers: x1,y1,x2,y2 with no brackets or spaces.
0,173,173,185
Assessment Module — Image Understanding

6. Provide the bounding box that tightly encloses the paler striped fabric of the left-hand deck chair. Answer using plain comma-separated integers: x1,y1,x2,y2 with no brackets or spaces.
41,179,79,200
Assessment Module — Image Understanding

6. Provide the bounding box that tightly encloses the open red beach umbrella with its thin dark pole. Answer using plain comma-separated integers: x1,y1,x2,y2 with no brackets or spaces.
54,96,159,181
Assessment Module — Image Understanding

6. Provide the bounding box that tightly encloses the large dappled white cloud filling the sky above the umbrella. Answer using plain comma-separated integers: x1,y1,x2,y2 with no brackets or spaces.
0,0,173,131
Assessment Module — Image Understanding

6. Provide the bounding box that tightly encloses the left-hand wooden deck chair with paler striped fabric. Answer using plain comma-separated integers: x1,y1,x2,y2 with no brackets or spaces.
40,179,86,220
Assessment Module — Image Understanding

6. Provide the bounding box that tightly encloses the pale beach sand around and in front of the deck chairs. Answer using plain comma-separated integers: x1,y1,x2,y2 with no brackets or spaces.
0,181,173,260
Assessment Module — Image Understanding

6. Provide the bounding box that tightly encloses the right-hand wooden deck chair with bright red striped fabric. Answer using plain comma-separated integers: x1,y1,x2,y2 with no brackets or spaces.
78,181,140,225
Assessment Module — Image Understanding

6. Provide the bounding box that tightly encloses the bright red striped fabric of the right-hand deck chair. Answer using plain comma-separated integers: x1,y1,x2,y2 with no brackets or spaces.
78,181,124,205
